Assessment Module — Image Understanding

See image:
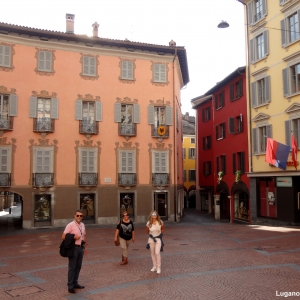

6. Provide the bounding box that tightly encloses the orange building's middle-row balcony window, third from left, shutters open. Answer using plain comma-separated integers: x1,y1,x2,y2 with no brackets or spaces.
75,100,102,134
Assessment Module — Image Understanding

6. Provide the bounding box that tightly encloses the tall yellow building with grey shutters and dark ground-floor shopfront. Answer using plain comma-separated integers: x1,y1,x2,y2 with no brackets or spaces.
239,0,300,224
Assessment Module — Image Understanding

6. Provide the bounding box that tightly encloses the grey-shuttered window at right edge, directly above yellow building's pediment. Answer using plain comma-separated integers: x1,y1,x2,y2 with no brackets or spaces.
282,63,300,97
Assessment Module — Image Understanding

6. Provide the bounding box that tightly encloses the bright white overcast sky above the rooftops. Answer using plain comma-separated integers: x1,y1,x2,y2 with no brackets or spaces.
0,0,246,116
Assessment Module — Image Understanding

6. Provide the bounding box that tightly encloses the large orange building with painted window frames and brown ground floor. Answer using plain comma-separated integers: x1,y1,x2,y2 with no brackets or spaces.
0,15,189,228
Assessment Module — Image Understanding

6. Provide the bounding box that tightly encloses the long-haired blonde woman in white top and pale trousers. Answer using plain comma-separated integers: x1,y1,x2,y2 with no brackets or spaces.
146,210,164,274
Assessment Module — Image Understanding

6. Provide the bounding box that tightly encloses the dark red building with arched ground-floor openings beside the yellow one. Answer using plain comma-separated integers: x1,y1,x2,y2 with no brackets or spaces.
192,67,250,222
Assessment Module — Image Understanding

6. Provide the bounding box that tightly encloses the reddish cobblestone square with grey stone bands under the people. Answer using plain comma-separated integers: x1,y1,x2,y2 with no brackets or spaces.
0,210,300,300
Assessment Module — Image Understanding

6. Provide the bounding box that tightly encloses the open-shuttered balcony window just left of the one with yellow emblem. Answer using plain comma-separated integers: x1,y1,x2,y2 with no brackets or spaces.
115,103,140,136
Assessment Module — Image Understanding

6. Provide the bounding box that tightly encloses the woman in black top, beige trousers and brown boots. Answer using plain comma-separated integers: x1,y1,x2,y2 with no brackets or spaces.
114,211,135,265
